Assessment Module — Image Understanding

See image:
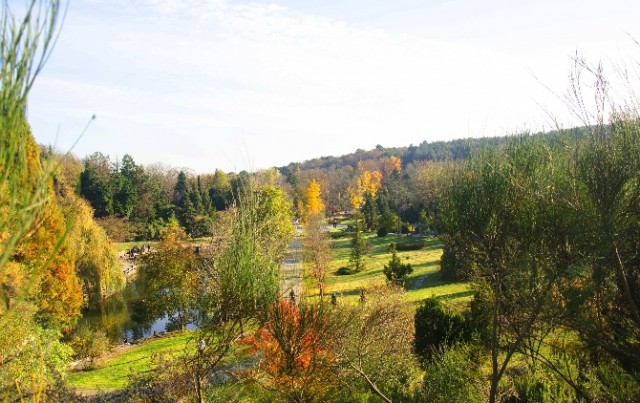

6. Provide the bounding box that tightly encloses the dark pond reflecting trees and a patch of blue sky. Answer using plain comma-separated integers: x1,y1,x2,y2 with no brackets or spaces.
78,270,194,343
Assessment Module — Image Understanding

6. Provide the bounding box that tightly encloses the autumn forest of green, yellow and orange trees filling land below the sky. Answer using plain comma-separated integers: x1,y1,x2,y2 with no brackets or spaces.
0,1,640,402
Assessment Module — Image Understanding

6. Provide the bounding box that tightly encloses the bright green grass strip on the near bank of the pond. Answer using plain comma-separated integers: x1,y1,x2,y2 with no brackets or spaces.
67,332,192,391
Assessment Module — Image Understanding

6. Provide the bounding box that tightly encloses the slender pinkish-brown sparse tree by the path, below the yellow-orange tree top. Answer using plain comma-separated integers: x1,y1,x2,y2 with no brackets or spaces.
303,214,331,296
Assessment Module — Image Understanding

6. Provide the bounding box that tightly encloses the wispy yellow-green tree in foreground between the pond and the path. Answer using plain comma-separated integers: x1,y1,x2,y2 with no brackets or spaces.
183,177,295,401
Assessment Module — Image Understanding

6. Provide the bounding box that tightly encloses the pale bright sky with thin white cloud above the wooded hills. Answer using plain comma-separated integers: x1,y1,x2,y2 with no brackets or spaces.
22,0,640,173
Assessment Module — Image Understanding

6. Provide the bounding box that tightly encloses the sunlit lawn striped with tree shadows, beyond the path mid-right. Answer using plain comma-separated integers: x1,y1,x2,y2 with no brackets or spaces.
305,234,472,309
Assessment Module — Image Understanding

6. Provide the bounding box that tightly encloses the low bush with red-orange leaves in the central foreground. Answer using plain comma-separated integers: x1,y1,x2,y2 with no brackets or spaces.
246,300,338,402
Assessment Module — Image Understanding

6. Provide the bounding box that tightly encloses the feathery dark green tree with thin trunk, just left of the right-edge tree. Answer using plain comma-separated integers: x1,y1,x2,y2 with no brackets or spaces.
441,137,578,402
